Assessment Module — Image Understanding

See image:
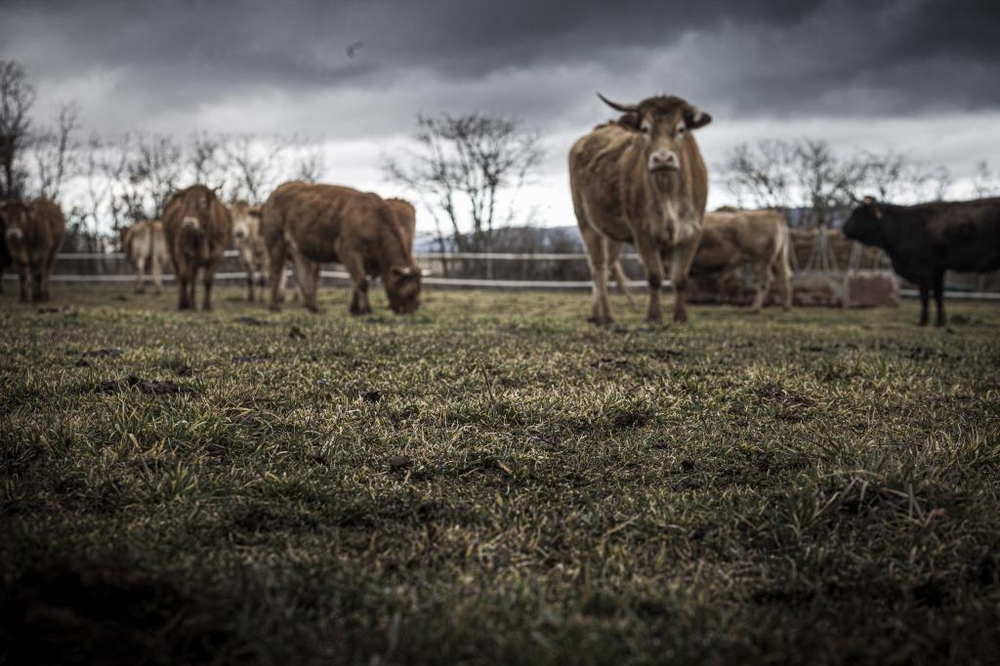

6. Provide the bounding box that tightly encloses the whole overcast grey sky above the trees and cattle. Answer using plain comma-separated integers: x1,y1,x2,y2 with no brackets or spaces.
0,0,1000,230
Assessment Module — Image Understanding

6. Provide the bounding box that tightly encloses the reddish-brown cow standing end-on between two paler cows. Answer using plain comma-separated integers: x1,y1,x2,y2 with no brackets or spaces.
163,185,233,310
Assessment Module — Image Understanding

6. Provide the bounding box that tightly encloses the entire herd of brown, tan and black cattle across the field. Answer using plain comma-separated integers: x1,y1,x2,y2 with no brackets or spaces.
0,90,1000,326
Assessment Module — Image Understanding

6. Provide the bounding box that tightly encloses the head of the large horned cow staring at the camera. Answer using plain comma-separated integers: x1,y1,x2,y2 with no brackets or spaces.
597,93,712,172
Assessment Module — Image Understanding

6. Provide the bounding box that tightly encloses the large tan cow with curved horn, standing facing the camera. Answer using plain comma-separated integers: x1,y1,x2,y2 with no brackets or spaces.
569,94,712,324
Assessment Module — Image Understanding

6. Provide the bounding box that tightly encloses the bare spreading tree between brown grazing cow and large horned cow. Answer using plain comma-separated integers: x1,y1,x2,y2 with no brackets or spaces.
383,113,544,251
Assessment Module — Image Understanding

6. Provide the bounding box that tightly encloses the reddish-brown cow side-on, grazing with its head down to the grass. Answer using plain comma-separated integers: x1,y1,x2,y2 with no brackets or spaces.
263,182,421,315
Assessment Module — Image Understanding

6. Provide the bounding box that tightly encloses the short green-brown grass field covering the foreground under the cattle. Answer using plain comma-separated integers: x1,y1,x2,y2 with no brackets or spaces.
0,284,1000,666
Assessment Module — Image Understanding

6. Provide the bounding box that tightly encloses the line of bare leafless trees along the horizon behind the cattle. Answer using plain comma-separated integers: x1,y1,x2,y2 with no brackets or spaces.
7,60,1000,252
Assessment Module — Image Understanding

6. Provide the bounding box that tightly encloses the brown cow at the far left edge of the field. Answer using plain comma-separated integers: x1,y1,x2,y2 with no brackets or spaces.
0,198,66,303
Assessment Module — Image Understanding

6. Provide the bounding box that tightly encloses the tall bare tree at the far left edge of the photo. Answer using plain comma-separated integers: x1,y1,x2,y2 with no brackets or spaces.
0,60,35,199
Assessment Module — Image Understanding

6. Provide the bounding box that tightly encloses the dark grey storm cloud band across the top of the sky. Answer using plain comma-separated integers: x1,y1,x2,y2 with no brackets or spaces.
0,0,1000,135
